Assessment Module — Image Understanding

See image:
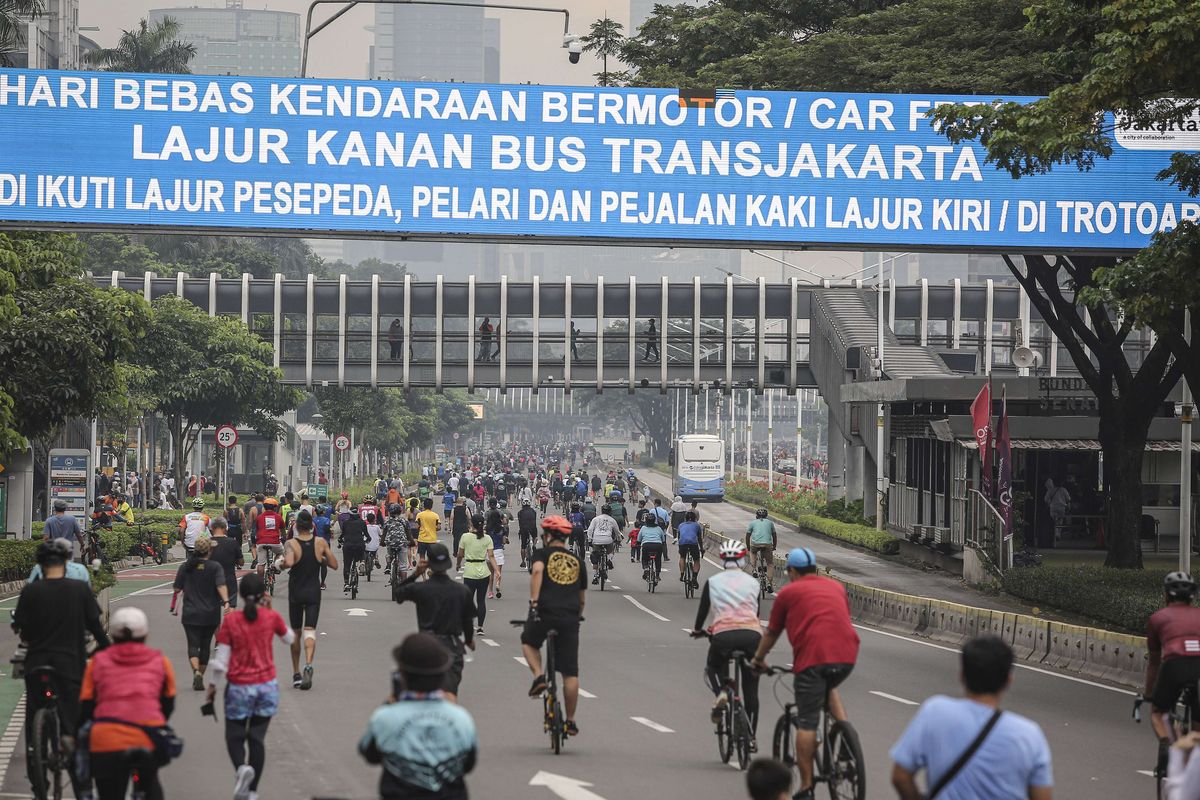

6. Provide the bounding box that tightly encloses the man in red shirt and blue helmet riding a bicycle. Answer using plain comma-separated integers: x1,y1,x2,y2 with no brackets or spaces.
751,547,858,800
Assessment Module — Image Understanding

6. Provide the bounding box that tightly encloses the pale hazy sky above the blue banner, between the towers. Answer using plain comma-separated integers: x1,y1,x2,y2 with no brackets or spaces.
79,0,629,84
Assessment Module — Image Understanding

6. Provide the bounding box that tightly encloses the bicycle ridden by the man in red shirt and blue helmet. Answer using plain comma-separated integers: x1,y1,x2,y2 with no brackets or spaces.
766,667,866,800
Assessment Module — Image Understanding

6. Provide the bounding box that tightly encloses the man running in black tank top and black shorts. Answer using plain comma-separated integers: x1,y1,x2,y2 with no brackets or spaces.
283,510,337,690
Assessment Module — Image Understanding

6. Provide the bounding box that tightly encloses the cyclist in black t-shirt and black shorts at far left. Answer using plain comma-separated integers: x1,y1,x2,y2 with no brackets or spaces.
12,539,108,775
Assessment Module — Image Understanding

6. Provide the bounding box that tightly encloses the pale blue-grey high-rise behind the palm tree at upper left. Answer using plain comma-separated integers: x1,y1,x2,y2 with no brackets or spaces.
150,0,302,78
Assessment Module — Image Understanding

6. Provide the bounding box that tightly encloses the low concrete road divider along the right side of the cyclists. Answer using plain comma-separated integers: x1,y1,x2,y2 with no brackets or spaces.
706,529,1147,688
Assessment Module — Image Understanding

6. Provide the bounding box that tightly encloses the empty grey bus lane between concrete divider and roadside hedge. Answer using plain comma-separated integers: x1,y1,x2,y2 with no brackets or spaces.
638,469,1030,613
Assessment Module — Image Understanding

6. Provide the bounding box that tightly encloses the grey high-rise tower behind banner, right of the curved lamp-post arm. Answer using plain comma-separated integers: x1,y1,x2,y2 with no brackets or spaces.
367,5,500,83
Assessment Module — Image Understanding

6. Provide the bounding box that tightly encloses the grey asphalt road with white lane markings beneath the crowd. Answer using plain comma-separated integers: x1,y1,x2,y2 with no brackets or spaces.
0,537,1153,800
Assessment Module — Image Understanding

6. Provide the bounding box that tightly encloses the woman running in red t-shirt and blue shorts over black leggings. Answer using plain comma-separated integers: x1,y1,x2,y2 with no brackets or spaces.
205,575,295,800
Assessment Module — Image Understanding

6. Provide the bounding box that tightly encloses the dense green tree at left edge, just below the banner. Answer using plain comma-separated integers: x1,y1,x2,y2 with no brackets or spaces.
0,233,149,452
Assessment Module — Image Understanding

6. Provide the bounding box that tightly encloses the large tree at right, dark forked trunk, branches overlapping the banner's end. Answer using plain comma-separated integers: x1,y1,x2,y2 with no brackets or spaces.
935,0,1200,567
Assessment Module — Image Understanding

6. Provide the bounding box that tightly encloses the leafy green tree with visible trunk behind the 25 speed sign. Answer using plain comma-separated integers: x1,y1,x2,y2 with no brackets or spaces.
133,295,304,486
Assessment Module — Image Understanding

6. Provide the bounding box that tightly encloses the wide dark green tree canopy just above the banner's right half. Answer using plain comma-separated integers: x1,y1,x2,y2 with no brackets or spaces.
620,0,1069,95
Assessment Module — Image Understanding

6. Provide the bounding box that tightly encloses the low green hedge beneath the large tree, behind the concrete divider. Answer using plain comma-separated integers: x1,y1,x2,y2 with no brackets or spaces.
1001,566,1166,633
